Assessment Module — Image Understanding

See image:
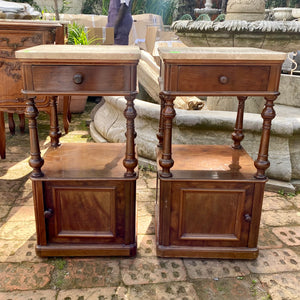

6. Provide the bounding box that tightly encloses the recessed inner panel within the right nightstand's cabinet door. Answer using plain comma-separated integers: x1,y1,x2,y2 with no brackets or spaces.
179,189,245,241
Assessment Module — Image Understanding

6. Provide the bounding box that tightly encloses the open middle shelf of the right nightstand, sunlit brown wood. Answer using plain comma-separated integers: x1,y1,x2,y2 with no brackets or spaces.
157,145,256,181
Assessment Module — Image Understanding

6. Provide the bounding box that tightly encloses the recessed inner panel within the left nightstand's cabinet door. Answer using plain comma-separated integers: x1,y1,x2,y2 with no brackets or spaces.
53,188,116,238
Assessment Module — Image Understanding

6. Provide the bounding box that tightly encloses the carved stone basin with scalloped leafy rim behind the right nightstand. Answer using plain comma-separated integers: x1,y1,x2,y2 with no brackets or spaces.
172,20,300,52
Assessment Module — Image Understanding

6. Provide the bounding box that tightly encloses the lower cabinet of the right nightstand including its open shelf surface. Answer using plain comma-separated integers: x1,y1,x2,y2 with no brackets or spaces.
156,145,265,259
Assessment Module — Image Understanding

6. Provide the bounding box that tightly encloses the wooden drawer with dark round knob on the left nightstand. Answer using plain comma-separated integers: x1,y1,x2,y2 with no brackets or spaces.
25,64,135,95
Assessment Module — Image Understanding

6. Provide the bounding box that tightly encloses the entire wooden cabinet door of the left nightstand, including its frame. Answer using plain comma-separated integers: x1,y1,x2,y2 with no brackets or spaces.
45,182,125,243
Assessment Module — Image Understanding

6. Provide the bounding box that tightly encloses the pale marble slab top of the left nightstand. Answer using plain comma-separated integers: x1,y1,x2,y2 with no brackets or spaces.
16,45,141,61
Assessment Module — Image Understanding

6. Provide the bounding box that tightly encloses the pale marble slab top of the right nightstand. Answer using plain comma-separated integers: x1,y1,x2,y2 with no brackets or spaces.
158,47,287,61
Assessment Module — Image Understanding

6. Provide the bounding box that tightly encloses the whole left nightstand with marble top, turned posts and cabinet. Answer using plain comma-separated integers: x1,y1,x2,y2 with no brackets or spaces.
16,45,140,256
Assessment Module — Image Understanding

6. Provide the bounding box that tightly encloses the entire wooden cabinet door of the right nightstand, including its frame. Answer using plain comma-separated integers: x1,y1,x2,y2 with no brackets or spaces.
170,182,253,247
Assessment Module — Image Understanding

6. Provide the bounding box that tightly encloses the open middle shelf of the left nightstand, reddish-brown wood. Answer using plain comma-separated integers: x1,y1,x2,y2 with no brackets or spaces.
38,143,135,181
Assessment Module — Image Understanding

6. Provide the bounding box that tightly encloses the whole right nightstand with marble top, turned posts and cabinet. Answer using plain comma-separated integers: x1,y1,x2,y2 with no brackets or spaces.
156,48,286,259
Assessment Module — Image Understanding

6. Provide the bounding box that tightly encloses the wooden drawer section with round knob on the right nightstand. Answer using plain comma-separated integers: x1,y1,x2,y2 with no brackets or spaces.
160,63,281,96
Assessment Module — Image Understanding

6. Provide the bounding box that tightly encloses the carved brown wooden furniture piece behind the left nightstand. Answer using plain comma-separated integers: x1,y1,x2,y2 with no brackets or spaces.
0,20,68,158
